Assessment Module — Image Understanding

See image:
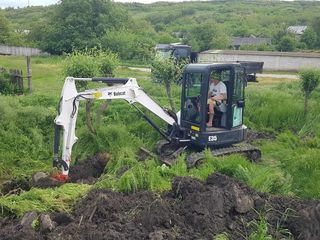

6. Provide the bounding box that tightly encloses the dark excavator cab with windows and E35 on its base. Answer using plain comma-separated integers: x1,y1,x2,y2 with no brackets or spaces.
180,63,247,147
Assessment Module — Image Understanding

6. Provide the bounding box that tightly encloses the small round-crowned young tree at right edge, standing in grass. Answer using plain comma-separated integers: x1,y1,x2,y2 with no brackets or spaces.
299,69,320,114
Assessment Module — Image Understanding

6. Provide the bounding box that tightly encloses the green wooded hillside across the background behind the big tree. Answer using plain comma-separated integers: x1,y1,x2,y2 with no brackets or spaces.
0,1,320,54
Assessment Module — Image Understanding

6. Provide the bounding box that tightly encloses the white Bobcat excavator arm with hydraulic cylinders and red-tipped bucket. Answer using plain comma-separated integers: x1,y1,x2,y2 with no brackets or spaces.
53,77,177,181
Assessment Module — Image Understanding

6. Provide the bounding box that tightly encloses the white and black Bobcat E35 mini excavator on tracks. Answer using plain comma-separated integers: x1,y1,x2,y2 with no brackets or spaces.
53,63,261,181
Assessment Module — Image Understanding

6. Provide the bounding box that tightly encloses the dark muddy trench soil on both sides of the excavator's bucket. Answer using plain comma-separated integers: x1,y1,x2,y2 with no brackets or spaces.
0,153,110,195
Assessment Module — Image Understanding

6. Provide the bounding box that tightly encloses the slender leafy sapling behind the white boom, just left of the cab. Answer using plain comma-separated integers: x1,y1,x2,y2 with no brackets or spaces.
151,56,186,112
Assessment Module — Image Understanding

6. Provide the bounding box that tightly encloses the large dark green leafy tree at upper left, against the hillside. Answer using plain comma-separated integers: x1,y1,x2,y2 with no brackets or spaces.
38,0,129,54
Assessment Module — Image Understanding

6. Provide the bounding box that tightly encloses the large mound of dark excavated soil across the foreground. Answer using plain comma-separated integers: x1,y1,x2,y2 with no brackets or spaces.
0,173,320,240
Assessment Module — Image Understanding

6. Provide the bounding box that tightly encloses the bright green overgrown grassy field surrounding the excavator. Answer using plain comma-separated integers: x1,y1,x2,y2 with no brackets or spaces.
0,57,320,215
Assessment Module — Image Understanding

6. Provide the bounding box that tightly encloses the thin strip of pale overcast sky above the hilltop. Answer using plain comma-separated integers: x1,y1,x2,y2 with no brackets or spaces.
0,0,205,8
